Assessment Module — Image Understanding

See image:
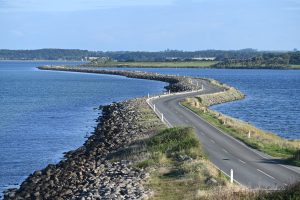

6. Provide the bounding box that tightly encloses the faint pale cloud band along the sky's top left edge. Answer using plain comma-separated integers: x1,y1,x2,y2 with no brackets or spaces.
0,0,175,12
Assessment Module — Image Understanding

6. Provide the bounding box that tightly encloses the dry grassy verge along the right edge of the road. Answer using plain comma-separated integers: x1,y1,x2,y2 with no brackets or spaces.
182,97,300,166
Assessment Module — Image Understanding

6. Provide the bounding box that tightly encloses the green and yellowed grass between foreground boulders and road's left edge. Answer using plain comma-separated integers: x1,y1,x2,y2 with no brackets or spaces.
109,101,300,200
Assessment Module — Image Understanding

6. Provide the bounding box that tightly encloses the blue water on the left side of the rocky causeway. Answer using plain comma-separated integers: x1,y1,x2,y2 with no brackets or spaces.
0,61,166,199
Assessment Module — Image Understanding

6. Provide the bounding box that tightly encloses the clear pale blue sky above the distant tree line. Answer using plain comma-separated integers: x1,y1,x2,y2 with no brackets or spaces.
0,0,300,51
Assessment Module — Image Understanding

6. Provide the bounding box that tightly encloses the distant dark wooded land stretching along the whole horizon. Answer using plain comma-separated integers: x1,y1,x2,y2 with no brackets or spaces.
0,49,300,69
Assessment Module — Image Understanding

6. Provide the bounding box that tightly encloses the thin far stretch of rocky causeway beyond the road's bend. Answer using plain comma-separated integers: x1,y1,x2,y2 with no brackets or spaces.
38,66,201,92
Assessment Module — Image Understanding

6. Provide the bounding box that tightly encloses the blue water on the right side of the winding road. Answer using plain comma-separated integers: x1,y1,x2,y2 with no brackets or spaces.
97,68,300,139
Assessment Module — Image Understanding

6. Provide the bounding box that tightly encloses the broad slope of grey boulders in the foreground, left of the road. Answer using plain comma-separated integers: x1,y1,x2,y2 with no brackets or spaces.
4,99,162,200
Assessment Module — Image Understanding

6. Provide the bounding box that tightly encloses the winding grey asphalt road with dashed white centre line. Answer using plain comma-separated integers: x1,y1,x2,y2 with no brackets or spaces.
151,80,300,189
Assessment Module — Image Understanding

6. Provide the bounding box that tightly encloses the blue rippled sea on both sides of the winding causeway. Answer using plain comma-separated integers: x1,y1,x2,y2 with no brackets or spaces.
0,61,300,199
